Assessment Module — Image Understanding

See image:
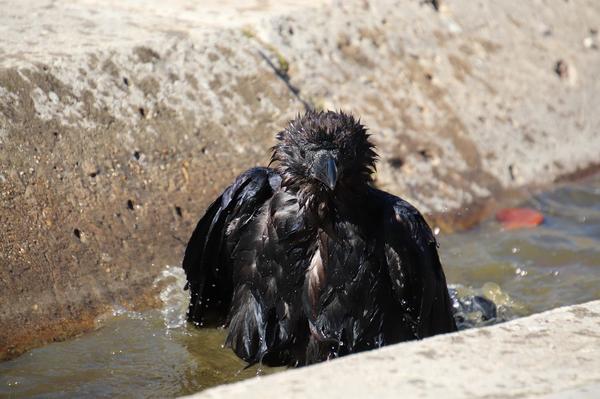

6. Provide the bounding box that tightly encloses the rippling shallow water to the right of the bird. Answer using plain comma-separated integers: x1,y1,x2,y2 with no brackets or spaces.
439,176,600,315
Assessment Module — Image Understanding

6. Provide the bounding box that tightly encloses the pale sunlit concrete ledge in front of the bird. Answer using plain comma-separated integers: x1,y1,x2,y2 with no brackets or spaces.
189,301,600,399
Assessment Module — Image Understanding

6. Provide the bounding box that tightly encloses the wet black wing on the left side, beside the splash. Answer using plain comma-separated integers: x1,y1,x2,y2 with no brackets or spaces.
183,168,281,325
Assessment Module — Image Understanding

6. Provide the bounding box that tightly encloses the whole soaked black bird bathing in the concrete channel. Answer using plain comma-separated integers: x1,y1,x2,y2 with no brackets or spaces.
183,111,456,366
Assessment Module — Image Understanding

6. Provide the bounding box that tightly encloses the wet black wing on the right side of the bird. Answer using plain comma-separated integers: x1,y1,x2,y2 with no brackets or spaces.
370,189,456,338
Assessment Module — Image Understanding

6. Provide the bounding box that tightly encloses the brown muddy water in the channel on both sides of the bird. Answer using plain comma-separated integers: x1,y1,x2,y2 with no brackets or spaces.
0,176,600,398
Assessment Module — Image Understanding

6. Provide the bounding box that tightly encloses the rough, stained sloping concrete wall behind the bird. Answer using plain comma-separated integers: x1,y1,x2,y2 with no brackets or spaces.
0,0,600,359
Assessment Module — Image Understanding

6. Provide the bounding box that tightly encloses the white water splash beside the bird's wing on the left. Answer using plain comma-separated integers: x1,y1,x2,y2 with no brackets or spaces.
154,265,190,329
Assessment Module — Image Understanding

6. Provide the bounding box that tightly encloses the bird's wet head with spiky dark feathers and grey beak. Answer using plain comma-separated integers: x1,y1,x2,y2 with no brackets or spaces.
271,111,377,203
